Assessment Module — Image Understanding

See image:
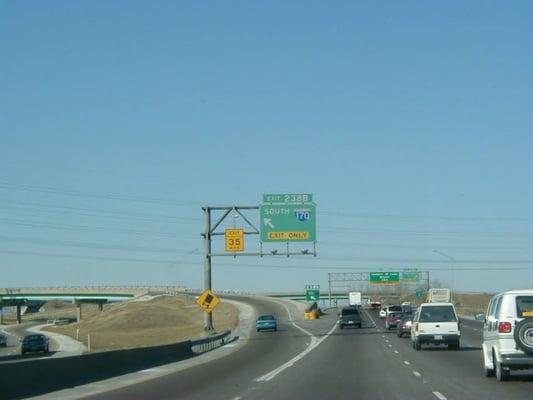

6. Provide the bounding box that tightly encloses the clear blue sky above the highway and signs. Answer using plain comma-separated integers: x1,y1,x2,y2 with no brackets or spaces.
0,1,533,291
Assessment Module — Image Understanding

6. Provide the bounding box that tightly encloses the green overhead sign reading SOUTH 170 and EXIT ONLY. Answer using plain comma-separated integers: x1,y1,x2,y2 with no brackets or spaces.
259,203,316,242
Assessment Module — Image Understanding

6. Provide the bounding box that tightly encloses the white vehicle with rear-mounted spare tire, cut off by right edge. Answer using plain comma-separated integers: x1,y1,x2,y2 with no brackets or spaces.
476,289,533,381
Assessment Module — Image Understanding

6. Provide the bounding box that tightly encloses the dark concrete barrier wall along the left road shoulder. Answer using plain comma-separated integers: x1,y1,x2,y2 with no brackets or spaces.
0,339,195,400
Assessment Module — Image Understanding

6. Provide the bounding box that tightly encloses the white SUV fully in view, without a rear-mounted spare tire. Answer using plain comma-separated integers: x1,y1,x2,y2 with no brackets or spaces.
411,303,461,350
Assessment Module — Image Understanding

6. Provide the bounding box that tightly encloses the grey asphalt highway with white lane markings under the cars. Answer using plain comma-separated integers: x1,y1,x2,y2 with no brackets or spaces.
79,299,533,400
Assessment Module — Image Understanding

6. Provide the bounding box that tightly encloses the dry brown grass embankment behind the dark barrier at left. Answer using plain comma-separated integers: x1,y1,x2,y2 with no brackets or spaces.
42,295,238,350
